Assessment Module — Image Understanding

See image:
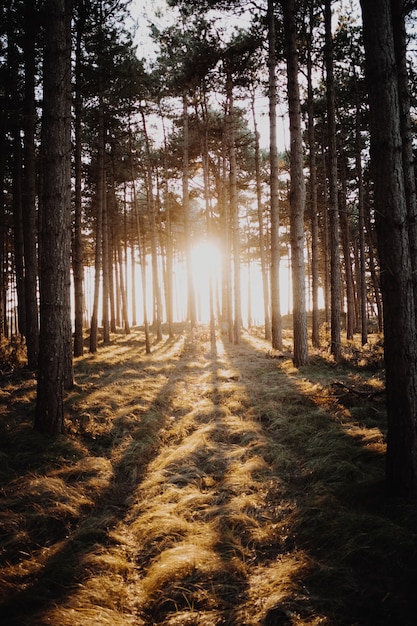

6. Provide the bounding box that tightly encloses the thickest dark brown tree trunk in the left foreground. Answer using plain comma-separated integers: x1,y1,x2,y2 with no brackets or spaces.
34,0,71,435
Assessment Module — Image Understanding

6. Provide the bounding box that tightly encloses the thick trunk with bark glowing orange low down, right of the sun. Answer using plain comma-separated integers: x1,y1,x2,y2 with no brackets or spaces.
282,0,308,367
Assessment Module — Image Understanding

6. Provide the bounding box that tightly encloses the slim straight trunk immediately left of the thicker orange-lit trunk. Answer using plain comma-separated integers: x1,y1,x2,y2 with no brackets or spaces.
268,0,282,350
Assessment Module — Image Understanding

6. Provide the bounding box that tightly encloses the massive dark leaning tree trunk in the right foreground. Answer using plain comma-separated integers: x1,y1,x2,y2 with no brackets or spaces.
361,0,417,498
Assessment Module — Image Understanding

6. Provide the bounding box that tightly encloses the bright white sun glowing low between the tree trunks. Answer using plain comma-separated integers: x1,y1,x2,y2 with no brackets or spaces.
191,239,221,323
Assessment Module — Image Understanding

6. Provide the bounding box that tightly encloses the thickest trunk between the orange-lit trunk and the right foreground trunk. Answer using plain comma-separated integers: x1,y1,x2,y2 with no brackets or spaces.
324,0,342,361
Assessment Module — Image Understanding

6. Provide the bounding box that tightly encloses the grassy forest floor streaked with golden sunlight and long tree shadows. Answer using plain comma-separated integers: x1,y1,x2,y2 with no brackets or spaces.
0,329,417,626
